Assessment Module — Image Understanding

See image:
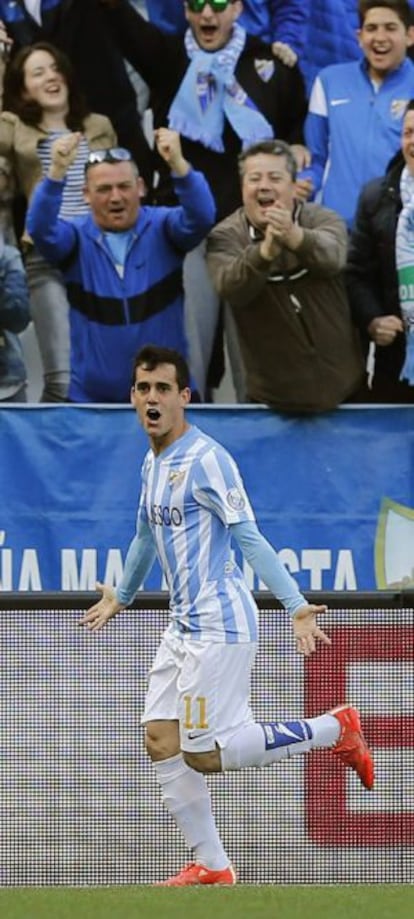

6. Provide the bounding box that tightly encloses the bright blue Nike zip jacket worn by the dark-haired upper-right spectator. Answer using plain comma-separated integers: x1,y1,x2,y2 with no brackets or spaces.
305,58,414,227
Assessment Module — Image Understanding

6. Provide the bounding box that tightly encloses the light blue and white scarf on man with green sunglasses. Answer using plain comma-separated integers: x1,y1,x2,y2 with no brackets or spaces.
168,23,274,153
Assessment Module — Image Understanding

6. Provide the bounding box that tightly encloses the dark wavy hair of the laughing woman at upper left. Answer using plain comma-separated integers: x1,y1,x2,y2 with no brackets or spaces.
3,41,89,131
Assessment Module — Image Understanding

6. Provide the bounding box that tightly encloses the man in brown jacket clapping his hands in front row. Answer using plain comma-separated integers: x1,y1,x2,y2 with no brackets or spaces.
207,140,363,413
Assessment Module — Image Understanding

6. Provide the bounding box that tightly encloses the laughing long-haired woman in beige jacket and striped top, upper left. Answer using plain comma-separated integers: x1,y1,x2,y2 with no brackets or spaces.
0,39,116,402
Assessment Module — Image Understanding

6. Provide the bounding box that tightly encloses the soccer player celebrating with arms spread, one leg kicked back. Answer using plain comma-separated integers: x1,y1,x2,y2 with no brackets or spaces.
81,346,374,887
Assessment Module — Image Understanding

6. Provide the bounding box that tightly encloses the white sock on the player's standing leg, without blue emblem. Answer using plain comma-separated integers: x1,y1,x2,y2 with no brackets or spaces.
153,753,230,871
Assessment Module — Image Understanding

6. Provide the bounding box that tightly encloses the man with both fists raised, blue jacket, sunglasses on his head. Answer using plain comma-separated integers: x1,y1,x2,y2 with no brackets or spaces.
27,128,215,402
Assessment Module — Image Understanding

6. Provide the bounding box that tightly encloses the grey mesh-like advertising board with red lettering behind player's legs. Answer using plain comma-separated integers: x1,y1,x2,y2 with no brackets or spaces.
0,591,414,886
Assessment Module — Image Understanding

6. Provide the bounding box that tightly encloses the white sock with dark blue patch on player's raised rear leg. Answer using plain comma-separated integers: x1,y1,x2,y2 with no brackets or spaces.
221,715,340,770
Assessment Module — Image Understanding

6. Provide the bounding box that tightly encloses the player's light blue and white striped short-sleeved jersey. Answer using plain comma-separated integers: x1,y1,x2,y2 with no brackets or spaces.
138,426,257,643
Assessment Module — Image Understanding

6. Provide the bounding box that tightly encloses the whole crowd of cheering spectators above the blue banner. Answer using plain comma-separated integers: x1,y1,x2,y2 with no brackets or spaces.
0,0,414,414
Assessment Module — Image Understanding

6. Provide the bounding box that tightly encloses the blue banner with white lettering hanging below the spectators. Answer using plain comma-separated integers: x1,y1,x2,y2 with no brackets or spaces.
0,405,414,591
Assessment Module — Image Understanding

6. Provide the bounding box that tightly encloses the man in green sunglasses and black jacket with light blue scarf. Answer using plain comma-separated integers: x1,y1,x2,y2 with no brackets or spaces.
99,0,307,401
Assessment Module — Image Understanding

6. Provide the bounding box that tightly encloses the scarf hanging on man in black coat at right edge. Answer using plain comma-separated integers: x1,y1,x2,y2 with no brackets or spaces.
395,166,414,386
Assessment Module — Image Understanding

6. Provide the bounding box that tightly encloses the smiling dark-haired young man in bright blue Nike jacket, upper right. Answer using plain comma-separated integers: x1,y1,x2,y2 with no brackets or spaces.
305,0,414,227
